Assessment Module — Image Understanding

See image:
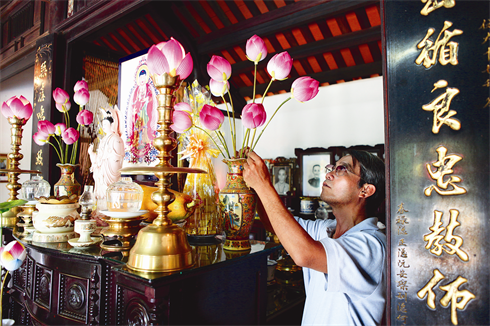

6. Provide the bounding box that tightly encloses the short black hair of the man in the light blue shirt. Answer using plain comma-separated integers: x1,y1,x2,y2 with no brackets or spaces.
348,150,385,220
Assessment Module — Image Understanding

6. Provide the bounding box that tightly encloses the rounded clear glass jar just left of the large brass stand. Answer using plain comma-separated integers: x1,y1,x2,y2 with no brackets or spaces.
107,177,143,212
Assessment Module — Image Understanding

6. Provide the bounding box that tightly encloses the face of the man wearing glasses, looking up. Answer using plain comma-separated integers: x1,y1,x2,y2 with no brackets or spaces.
320,155,361,206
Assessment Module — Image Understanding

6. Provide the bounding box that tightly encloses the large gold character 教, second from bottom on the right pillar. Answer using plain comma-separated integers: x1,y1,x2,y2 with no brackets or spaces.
424,209,469,261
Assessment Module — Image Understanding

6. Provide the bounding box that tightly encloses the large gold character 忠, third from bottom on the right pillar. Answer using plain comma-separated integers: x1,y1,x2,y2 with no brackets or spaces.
424,146,466,197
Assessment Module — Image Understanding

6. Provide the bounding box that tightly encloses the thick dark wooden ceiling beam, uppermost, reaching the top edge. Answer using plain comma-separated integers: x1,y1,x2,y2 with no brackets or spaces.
197,0,379,54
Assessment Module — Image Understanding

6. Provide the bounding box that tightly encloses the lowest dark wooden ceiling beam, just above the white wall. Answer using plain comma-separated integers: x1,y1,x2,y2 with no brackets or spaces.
238,61,383,97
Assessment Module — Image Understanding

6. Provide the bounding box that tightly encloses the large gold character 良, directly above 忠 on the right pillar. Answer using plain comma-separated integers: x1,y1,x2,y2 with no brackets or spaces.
422,79,461,134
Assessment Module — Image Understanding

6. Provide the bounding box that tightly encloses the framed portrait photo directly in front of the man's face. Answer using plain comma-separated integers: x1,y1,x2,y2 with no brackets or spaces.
295,148,335,197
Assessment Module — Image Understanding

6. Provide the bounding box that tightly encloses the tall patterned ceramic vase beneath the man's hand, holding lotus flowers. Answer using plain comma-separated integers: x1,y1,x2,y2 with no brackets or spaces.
219,159,257,251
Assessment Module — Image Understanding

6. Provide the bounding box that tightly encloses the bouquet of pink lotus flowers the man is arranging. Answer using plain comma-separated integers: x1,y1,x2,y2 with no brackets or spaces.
171,35,319,159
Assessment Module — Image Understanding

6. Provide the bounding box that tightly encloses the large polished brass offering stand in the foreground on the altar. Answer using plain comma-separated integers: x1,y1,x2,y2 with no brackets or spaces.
121,73,206,273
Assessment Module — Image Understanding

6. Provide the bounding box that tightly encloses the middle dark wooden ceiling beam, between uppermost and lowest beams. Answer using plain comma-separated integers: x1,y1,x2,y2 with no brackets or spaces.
232,26,381,74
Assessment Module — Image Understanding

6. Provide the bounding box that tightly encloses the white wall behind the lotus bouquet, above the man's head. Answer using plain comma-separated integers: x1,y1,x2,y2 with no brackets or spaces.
214,77,384,188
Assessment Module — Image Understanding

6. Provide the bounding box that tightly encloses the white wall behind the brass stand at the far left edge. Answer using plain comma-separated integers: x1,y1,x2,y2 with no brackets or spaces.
0,67,34,202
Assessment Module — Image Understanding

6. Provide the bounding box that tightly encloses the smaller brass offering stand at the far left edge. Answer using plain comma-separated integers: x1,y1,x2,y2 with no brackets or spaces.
0,117,41,227
